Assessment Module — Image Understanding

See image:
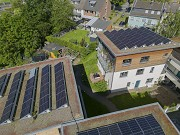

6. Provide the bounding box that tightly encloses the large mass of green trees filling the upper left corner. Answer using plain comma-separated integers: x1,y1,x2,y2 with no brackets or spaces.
0,0,74,66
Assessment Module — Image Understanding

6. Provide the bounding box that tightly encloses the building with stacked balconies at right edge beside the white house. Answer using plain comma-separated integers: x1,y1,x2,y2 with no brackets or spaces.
165,48,180,90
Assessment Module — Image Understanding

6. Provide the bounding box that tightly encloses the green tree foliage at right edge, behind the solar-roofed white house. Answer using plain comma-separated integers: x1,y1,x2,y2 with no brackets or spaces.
156,12,180,38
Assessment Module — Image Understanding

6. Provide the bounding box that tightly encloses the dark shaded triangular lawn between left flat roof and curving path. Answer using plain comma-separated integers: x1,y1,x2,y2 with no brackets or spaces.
82,92,109,117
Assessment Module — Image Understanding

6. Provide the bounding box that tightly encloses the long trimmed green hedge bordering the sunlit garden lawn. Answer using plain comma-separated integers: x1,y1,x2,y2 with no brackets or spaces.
46,36,88,57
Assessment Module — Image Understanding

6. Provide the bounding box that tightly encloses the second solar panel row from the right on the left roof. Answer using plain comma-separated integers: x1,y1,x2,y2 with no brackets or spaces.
39,65,51,113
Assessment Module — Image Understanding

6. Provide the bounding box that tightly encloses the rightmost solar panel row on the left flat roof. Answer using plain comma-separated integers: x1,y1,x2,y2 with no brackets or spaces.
54,62,67,108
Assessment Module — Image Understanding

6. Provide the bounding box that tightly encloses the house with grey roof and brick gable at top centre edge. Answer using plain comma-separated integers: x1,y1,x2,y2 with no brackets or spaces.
71,0,111,20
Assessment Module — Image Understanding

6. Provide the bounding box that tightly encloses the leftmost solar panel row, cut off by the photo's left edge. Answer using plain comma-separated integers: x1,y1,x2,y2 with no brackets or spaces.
0,74,11,97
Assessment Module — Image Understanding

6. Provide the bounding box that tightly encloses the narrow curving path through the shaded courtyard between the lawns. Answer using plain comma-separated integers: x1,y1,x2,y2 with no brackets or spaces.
74,65,118,112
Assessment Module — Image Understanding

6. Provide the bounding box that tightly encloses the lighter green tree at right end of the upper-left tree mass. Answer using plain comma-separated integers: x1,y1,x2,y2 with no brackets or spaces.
51,0,75,33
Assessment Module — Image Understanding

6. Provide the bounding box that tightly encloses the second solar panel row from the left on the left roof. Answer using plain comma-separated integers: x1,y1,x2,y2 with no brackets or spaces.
1,71,24,123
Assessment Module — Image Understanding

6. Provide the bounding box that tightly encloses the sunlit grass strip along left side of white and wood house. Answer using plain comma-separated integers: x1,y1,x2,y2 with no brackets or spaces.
81,51,107,92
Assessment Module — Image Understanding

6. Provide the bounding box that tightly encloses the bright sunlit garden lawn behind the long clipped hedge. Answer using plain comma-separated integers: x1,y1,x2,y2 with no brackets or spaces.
61,30,90,43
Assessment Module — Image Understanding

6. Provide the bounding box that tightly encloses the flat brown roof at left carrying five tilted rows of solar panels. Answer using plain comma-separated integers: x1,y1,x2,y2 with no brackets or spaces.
0,58,84,135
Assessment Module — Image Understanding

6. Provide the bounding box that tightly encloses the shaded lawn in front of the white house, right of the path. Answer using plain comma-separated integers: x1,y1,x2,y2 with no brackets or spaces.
110,92,158,110
